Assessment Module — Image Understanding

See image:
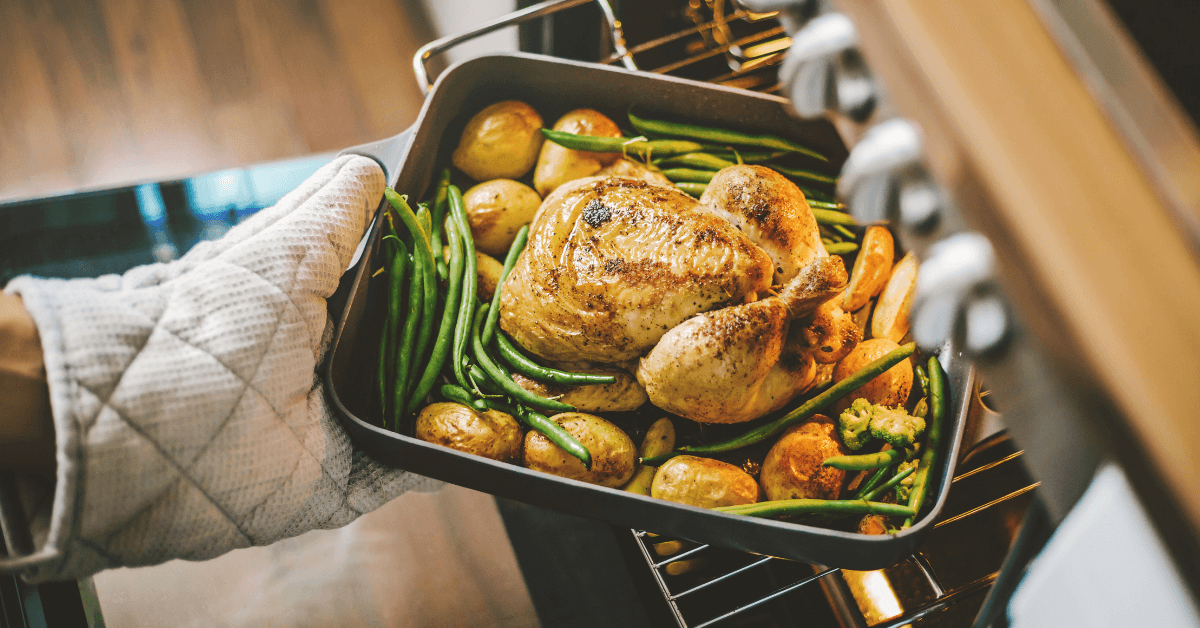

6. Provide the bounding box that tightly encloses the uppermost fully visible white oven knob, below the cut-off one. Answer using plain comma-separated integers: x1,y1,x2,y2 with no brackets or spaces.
779,13,876,122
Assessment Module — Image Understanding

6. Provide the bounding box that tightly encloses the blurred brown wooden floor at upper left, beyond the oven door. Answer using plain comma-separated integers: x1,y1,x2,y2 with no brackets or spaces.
0,0,432,202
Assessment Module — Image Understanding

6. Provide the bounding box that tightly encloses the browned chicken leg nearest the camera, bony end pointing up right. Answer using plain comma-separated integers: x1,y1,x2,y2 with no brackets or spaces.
637,256,848,423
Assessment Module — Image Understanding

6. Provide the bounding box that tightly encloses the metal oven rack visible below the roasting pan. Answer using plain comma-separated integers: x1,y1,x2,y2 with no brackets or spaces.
630,436,1039,628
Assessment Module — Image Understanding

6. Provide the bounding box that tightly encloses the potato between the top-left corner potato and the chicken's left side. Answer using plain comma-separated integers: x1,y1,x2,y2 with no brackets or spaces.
462,179,541,257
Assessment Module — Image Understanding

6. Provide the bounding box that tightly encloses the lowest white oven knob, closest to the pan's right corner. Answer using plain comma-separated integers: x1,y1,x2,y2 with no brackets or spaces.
910,232,1012,358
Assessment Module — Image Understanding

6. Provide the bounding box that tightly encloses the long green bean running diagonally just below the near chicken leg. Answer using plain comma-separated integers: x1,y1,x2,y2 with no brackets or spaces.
642,342,917,467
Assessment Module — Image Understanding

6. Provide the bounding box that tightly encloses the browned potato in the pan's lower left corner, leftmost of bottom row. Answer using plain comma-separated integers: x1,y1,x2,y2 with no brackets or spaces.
416,402,521,462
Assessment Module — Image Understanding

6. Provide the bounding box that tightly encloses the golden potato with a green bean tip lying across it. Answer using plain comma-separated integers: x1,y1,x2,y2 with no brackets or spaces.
524,412,637,489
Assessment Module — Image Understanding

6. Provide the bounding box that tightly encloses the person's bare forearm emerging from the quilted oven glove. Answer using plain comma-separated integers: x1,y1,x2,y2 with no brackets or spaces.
0,293,54,473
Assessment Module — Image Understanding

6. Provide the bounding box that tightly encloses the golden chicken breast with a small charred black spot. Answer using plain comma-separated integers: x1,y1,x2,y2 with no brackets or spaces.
500,178,772,364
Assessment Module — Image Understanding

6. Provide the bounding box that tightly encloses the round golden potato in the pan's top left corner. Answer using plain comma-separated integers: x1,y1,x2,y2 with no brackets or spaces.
450,101,544,181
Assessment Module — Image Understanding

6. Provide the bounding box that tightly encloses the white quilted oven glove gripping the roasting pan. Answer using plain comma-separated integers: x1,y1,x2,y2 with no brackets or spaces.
0,156,439,581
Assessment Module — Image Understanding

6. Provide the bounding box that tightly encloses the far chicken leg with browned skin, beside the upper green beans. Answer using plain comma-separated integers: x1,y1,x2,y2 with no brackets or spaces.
700,166,829,285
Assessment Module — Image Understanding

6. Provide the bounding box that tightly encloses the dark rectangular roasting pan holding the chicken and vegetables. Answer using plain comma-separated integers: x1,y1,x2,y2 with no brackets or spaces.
325,54,974,569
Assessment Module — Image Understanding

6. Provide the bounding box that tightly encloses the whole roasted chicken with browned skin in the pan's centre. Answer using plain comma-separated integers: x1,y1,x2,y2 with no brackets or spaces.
500,166,862,423
